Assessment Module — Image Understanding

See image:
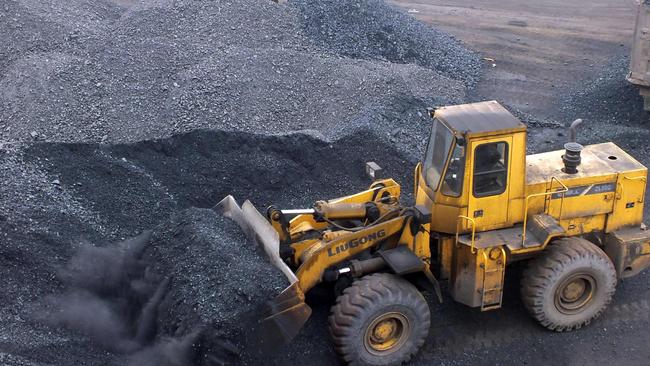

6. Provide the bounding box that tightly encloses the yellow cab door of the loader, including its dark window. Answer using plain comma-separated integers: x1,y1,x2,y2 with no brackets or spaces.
467,136,512,231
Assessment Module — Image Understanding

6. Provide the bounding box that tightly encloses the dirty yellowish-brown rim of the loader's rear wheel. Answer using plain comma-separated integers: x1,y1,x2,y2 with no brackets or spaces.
555,273,596,314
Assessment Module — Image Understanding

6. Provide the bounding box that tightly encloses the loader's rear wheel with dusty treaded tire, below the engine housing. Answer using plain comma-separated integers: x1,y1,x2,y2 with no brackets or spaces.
521,238,616,332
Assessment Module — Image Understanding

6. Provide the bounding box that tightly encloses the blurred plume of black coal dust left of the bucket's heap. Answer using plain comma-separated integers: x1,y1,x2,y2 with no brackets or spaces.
39,232,156,353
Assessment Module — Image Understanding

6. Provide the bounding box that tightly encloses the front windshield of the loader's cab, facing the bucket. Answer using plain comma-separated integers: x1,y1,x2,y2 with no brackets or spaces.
423,119,454,190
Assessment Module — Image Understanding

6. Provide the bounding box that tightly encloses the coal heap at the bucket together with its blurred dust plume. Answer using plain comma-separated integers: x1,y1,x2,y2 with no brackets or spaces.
39,208,288,366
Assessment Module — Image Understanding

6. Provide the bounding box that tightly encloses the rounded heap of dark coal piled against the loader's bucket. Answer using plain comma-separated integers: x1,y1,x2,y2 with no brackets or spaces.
144,208,288,365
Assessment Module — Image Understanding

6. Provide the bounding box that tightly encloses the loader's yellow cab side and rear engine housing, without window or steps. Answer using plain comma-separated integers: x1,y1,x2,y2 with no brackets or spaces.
416,133,647,236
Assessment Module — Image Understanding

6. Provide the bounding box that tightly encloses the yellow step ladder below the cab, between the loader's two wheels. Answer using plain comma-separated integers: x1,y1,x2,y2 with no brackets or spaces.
480,247,506,311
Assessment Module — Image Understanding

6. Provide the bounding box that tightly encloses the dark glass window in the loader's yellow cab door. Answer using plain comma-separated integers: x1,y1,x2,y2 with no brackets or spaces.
473,142,508,197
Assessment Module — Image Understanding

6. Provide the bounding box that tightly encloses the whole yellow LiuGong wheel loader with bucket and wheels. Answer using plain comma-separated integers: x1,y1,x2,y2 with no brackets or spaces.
217,101,650,365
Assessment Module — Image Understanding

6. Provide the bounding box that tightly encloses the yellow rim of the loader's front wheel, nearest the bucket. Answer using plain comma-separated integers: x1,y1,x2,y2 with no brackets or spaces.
364,312,411,355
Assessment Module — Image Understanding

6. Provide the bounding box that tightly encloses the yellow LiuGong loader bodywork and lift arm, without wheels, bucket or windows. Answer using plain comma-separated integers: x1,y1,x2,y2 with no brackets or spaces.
262,102,650,316
